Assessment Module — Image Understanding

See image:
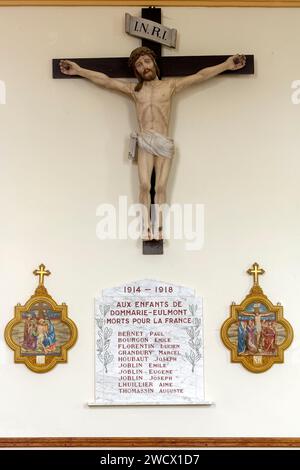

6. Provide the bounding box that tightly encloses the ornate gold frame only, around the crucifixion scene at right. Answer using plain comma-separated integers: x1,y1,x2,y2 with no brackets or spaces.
221,263,293,373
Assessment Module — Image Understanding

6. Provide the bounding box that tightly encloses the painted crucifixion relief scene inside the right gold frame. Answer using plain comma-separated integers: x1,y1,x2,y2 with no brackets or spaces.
228,302,286,356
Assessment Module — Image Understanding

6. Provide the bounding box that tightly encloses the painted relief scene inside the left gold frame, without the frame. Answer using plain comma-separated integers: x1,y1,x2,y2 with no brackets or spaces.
12,302,70,356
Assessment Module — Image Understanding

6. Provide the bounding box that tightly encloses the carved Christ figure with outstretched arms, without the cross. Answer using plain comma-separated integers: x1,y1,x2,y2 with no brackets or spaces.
60,47,246,240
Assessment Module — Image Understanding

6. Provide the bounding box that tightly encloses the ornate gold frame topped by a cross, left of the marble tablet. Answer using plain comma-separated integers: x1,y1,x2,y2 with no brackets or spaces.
4,264,78,373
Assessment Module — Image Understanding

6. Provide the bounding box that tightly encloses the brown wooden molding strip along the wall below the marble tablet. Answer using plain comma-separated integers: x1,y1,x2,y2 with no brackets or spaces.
0,437,300,448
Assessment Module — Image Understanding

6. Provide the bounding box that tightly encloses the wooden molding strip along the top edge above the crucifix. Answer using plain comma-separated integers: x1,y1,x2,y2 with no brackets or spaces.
0,0,300,8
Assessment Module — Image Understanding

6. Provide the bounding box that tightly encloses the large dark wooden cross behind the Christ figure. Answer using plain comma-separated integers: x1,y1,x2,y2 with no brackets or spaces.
52,7,254,254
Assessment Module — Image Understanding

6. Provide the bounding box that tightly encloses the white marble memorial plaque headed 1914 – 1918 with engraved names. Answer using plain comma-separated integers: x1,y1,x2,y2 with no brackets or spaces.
95,280,204,405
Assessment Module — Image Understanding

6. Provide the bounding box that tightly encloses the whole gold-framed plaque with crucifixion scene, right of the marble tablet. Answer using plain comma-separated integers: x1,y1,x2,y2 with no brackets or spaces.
221,263,293,372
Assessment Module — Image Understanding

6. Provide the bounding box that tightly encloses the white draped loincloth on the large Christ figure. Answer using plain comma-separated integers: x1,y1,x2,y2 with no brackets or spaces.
133,131,174,158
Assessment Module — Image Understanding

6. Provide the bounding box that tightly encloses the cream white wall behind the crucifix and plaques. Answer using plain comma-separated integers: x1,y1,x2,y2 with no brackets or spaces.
0,7,300,436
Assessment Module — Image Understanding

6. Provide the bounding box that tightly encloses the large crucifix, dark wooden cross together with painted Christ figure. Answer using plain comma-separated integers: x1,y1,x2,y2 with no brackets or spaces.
53,7,254,254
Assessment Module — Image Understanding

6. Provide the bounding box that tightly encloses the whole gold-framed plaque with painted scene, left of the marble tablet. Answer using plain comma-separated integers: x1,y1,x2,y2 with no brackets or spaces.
4,264,77,373
